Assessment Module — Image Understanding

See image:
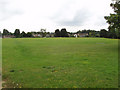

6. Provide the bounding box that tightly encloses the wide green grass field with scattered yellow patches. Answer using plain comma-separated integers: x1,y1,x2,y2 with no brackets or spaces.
2,38,118,88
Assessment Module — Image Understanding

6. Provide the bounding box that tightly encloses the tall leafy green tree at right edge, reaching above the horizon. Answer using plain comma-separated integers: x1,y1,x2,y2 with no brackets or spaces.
104,1,120,38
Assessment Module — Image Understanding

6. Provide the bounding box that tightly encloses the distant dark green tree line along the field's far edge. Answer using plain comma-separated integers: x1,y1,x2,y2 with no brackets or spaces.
2,28,116,38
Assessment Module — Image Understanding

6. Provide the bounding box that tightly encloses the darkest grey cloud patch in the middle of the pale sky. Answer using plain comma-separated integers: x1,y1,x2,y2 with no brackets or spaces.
54,9,91,26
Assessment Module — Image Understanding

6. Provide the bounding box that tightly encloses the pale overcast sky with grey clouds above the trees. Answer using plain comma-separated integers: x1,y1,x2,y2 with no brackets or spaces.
0,0,113,32
